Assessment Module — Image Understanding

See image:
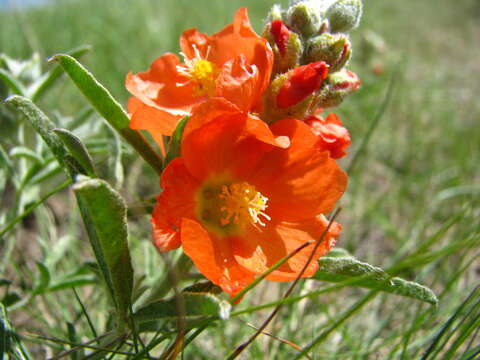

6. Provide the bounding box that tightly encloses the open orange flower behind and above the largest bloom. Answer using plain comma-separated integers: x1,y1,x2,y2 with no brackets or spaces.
126,9,273,143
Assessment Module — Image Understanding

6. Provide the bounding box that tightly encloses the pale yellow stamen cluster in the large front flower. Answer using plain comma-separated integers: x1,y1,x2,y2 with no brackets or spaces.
218,182,270,226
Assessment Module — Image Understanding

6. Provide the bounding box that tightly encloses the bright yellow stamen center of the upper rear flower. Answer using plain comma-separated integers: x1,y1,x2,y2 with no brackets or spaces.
177,46,219,96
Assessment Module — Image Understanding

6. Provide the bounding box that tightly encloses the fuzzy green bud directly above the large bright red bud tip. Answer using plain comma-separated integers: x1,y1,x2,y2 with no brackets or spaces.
305,33,351,74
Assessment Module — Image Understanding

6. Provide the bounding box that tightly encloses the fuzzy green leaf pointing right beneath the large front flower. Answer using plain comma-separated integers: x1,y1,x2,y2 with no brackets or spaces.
313,256,438,305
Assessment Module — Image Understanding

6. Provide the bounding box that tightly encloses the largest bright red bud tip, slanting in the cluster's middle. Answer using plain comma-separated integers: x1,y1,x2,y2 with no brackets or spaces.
277,61,328,109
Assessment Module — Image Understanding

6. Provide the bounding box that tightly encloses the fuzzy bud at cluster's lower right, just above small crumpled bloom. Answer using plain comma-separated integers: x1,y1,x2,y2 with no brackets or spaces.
315,69,360,108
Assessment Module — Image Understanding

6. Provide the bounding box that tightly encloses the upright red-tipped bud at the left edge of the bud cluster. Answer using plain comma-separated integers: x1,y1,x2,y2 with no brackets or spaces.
264,20,303,74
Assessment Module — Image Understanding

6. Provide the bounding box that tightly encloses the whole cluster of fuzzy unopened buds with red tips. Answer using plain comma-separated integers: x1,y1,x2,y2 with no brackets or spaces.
262,0,362,123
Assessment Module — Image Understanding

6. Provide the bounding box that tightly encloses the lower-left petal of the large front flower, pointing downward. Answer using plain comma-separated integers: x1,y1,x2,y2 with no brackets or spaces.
181,219,254,297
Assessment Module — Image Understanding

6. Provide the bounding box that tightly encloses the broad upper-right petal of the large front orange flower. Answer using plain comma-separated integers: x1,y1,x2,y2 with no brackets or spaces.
247,119,347,222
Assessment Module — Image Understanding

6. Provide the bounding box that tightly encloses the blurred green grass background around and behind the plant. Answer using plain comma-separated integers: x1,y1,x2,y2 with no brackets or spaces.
0,0,480,360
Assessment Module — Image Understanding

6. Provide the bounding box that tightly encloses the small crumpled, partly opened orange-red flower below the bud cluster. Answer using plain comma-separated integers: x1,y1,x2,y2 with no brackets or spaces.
305,113,350,159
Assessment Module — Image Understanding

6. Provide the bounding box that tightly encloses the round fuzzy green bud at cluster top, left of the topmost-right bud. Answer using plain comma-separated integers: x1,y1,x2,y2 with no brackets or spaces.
287,2,321,38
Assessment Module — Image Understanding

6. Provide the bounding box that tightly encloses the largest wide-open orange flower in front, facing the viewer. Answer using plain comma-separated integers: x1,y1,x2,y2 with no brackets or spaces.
152,100,347,296
